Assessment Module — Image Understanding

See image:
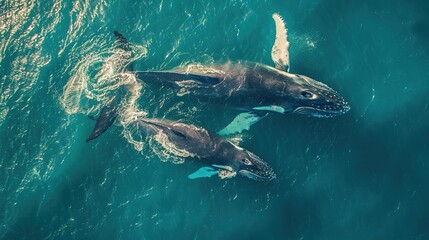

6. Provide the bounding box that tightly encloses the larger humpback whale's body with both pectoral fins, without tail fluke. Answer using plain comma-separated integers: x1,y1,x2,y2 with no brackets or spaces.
135,13,350,135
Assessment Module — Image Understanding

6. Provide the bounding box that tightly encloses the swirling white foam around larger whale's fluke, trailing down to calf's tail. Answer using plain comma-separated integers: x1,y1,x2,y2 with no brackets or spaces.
60,34,147,147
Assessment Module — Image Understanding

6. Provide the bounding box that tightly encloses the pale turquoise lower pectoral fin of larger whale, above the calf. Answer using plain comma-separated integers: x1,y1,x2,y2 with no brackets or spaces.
217,112,268,136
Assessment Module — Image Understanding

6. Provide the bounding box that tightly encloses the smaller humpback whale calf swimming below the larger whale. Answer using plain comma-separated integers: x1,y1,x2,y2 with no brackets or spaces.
131,118,276,181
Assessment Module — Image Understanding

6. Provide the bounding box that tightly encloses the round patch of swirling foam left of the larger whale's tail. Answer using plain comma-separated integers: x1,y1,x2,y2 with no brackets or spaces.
60,38,147,114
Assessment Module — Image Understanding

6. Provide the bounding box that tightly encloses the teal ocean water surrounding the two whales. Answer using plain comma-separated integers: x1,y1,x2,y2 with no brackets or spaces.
0,0,429,240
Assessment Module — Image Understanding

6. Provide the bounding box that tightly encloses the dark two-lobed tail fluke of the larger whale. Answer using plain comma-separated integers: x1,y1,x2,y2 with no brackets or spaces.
86,31,132,142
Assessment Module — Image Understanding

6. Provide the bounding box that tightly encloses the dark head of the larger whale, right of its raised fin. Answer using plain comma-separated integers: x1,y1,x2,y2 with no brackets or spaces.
285,74,350,117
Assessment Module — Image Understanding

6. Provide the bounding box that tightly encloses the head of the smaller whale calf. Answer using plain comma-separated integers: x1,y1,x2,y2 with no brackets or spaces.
213,144,276,181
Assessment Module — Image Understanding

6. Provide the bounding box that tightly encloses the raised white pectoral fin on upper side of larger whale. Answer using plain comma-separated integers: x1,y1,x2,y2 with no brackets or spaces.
271,13,289,72
